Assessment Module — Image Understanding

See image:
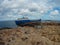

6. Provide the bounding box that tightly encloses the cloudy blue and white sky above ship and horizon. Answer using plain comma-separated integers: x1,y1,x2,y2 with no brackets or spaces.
0,0,60,20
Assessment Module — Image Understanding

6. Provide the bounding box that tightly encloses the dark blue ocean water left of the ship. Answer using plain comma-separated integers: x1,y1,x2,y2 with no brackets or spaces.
0,21,17,28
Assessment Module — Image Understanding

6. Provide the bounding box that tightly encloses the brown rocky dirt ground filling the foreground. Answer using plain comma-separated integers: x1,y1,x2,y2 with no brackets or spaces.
0,25,60,45
